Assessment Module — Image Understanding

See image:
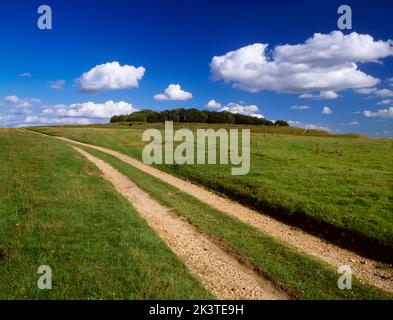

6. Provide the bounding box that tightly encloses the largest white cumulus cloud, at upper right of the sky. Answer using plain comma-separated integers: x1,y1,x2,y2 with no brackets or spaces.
210,31,393,98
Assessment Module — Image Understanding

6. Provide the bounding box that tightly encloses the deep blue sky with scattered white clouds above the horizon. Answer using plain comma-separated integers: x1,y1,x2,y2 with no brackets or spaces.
0,0,393,137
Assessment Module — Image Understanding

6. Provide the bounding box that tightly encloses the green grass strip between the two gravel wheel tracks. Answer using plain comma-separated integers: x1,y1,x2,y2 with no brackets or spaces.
75,142,393,299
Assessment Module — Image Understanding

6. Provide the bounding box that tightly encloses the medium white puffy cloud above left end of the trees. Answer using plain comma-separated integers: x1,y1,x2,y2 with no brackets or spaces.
76,61,146,92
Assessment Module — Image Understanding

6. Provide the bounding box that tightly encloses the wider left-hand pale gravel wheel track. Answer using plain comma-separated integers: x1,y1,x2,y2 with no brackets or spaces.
73,147,288,300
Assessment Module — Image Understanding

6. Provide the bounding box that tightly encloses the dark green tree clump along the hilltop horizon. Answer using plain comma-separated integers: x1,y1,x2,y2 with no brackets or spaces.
110,109,289,127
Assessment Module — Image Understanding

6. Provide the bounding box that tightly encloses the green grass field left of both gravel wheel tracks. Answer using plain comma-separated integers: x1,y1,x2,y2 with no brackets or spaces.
0,129,213,300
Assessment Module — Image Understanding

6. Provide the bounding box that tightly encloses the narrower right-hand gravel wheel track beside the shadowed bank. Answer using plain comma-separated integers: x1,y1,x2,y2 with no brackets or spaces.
22,129,393,293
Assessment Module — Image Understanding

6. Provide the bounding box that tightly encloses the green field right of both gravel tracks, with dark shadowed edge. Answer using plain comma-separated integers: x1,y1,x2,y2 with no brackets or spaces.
34,124,393,259
